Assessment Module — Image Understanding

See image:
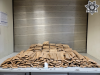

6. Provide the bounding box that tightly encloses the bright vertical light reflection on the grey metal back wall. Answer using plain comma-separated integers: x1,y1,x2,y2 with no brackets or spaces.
33,1,46,43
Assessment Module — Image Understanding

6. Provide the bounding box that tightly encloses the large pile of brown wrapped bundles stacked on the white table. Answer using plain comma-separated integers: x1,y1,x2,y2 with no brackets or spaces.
1,41,100,68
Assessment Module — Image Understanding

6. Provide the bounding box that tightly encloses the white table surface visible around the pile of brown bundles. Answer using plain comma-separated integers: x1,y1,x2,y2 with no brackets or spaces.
0,52,100,73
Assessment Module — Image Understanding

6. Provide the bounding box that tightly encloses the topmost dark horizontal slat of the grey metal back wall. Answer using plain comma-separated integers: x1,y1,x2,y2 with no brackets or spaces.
14,0,87,6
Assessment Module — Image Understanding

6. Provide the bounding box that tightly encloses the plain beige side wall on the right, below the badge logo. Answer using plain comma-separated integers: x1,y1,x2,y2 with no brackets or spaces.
87,0,100,59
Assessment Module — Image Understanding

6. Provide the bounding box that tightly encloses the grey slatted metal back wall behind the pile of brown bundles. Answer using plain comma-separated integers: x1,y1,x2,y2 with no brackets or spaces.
14,0,88,52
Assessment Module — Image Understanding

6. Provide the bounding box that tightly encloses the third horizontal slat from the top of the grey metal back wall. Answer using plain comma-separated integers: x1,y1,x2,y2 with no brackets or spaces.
14,11,86,19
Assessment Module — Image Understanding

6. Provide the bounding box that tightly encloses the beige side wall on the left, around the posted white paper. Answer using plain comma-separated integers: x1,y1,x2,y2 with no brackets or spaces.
0,0,13,58
